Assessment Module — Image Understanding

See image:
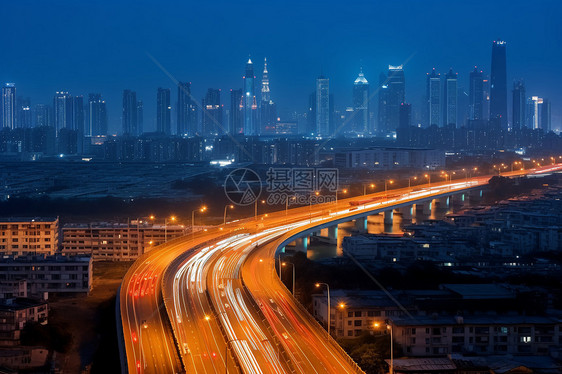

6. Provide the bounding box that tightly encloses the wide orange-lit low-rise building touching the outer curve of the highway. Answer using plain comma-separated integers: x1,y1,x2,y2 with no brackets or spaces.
62,221,186,261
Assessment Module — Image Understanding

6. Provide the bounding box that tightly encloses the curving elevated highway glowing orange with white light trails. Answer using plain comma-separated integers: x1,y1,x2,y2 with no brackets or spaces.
118,165,562,373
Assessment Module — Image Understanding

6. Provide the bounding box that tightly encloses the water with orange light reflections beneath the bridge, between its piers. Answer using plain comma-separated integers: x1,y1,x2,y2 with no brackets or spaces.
307,199,463,260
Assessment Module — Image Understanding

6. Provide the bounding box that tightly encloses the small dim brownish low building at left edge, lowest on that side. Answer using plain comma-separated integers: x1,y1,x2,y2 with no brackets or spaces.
0,298,49,346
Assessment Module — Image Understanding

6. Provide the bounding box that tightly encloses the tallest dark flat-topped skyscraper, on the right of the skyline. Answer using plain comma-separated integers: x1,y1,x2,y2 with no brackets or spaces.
490,40,507,129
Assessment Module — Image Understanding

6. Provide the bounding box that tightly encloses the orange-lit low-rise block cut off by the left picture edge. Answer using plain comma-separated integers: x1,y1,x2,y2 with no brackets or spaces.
0,217,59,256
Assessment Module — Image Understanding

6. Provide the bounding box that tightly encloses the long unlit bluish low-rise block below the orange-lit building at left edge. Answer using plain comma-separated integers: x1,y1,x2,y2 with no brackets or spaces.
0,255,92,298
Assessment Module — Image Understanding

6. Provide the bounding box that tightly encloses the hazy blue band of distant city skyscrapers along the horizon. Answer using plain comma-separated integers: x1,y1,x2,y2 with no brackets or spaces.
0,40,562,162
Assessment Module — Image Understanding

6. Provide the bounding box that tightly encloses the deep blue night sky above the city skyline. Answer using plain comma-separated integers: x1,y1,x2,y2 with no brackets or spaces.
0,0,562,133
